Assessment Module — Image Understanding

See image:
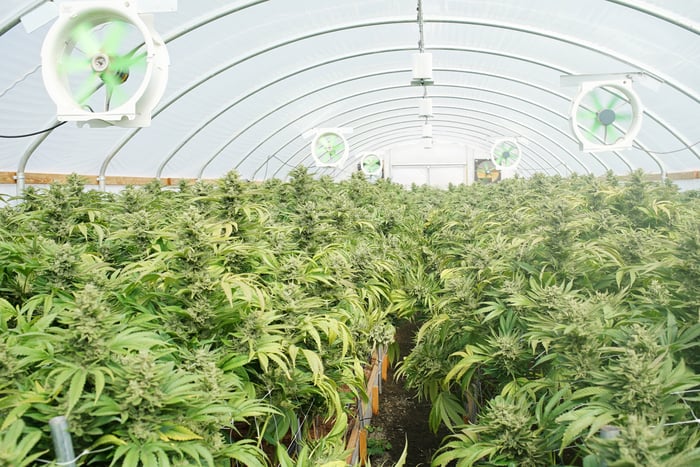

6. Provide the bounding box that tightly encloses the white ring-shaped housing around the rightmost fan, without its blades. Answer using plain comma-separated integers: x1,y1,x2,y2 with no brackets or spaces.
569,75,644,152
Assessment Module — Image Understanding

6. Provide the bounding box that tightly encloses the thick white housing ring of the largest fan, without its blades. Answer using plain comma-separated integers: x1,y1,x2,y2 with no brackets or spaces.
41,0,170,128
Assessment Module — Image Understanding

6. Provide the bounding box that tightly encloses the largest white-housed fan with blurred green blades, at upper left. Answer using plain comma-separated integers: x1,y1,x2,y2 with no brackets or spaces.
41,0,169,127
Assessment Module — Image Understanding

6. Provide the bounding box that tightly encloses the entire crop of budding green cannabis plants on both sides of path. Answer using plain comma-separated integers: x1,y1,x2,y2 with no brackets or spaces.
0,169,700,466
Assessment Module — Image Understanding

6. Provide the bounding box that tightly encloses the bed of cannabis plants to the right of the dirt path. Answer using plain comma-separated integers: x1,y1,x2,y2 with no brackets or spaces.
392,173,700,467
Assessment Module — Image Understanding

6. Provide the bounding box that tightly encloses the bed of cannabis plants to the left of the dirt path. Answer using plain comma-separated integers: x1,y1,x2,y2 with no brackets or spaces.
0,169,422,467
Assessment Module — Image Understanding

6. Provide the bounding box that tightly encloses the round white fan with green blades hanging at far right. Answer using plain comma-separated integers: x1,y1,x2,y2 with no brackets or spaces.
571,80,643,151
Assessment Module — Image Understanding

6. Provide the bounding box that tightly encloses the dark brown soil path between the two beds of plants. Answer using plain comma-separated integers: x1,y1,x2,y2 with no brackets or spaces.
368,323,448,467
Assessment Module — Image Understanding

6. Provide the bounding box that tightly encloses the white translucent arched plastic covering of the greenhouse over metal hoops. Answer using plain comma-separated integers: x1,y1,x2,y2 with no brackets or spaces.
0,0,700,194
